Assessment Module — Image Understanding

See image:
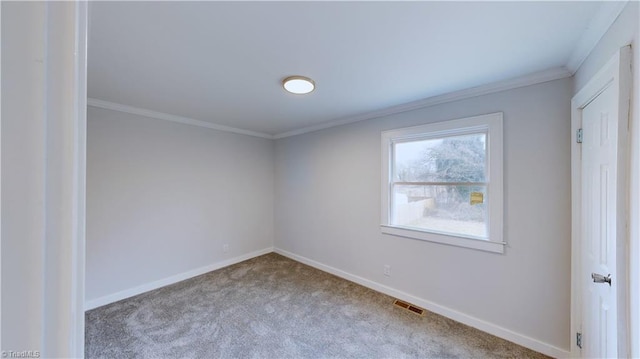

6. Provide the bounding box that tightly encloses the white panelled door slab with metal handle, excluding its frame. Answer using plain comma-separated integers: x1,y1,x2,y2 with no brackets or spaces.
582,82,618,358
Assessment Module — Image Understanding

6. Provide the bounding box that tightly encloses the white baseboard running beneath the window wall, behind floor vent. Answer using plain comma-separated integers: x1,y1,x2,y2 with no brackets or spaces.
274,248,571,358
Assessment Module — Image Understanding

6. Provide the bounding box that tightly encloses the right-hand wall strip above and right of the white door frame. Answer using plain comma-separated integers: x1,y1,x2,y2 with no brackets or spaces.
574,1,640,358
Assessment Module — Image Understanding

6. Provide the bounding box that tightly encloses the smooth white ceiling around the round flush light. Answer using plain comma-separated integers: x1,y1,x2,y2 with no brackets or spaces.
88,2,619,135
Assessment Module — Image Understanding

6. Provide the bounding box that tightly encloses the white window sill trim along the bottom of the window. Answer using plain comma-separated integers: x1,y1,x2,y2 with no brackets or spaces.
380,224,505,253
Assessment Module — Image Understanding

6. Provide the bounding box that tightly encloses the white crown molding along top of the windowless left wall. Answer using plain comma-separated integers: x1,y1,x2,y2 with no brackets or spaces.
87,98,273,140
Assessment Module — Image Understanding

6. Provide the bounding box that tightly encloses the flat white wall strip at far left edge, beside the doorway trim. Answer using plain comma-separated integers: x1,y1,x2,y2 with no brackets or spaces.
1,2,46,351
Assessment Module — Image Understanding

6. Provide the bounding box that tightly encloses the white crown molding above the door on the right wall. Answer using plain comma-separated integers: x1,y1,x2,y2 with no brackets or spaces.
567,0,628,75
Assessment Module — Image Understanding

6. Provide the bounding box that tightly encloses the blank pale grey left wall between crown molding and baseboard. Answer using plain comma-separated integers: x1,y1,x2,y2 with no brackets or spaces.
86,107,274,304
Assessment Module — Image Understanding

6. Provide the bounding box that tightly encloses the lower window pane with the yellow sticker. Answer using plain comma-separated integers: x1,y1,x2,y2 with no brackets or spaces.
391,185,489,239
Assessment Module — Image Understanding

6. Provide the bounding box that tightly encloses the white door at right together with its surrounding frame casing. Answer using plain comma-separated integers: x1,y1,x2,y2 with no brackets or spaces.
572,47,631,358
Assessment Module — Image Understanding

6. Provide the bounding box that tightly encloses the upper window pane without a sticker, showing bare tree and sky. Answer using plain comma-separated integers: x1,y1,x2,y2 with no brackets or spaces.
393,133,487,182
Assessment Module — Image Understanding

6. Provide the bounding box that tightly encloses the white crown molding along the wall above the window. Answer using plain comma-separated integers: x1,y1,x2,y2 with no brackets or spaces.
273,67,572,139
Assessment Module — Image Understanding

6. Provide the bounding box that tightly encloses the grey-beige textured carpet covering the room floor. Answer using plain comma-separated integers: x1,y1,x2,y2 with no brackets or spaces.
85,253,545,358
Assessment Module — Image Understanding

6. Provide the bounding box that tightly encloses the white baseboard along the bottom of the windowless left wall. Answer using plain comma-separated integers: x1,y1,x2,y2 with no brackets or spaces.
84,247,273,311
